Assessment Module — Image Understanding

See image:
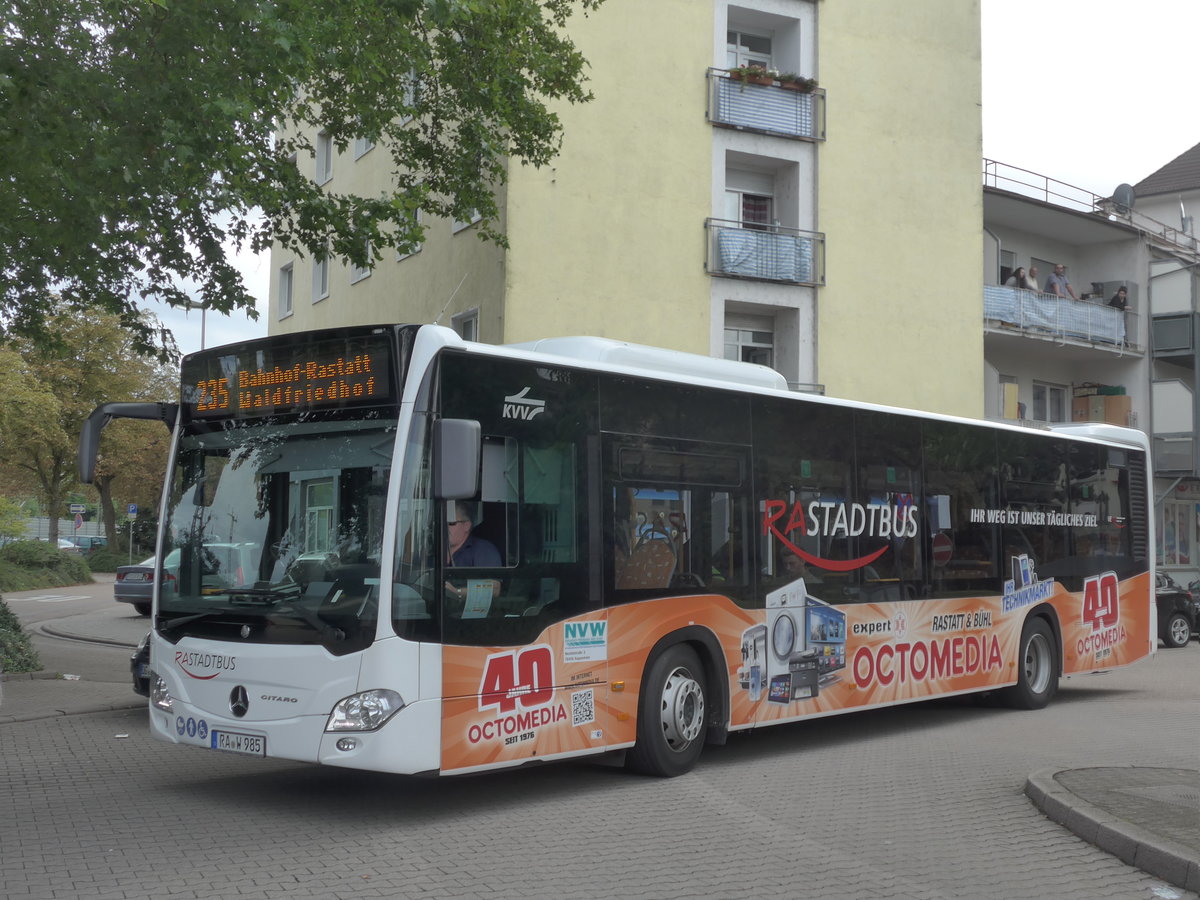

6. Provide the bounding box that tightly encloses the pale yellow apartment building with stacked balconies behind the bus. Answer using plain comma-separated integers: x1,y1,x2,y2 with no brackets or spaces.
269,0,984,415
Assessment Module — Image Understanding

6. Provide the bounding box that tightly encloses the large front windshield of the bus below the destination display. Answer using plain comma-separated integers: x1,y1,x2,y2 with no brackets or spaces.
157,419,396,654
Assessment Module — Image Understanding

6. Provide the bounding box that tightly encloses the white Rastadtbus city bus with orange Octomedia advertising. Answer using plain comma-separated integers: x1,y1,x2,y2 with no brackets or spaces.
80,325,1157,775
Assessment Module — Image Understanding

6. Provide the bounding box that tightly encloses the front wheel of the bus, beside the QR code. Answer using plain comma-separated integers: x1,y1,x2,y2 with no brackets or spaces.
628,643,708,778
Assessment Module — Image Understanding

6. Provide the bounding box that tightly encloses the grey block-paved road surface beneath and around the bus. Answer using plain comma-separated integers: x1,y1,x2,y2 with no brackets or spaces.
0,592,1200,900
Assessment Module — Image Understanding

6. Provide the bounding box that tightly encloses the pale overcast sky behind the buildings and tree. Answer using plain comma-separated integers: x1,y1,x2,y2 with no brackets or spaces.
160,0,1200,353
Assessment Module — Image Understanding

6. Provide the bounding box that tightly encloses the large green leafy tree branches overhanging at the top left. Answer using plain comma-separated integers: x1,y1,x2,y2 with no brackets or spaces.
0,0,601,353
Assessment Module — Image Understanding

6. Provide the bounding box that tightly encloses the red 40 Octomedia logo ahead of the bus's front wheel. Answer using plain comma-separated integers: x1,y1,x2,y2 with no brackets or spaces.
467,644,566,745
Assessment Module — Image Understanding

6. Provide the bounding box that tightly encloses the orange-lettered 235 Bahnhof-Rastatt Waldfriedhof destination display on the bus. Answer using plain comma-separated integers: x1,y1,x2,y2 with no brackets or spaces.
182,335,391,419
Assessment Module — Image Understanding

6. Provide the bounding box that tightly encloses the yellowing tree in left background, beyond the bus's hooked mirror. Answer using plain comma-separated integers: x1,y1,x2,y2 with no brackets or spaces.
0,306,166,542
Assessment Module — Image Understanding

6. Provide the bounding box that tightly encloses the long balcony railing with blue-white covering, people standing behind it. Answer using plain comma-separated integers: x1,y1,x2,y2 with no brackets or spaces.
983,284,1141,350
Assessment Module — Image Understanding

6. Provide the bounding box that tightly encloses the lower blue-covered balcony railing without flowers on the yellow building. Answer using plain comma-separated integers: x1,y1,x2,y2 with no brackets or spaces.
704,218,824,286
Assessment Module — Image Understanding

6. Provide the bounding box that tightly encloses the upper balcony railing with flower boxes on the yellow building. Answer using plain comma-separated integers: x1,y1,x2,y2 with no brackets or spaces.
708,68,826,140
